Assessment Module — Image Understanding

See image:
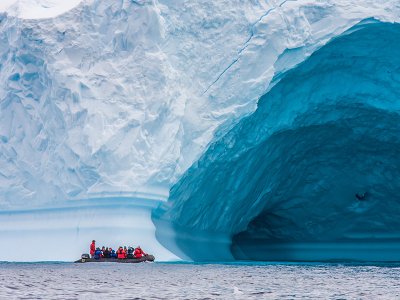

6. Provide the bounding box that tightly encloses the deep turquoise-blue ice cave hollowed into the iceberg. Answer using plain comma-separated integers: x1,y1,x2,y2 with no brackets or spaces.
153,21,400,261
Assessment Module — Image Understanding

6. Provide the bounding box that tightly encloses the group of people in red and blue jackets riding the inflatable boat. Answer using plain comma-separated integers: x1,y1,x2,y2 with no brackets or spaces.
90,240,147,259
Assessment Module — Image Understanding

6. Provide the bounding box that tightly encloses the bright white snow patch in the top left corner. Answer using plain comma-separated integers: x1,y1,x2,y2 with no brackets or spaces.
0,0,82,19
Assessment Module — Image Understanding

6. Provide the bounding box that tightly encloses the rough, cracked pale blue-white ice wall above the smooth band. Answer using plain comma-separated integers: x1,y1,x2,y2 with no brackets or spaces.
0,0,397,207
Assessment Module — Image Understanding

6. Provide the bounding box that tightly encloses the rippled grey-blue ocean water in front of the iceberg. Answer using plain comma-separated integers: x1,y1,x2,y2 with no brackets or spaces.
0,263,400,299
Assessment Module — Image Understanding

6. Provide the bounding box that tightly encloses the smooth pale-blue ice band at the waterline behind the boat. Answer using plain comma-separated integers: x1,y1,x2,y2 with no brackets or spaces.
0,195,179,262
